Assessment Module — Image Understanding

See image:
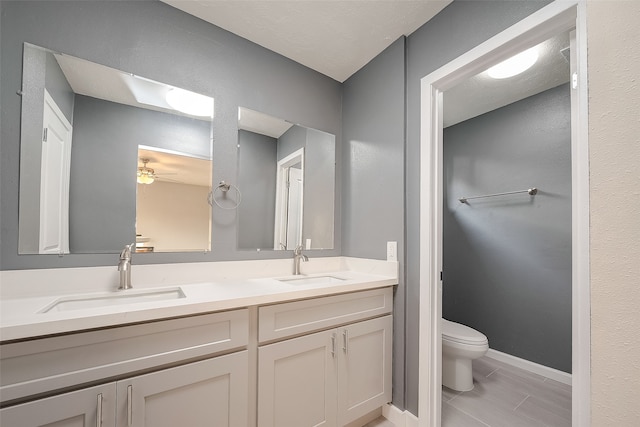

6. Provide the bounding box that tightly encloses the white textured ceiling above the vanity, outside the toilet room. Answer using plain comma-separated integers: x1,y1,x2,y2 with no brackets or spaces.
162,0,451,82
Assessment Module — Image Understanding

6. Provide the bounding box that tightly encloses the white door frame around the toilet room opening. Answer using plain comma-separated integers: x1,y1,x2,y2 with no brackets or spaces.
418,0,591,427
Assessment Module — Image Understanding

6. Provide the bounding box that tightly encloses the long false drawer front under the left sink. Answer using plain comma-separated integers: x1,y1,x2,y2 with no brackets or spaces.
0,309,249,402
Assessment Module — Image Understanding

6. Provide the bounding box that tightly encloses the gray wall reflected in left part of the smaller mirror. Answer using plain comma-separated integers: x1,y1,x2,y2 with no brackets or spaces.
238,130,278,250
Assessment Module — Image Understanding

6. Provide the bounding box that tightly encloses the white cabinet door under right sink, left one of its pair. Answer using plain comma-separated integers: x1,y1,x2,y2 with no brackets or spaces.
258,330,337,427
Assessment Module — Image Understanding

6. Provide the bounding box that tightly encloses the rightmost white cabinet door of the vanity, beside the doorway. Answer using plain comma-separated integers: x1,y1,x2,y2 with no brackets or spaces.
338,316,393,426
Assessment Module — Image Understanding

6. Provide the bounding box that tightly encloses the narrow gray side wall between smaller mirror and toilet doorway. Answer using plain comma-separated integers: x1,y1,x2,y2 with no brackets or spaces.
342,38,408,408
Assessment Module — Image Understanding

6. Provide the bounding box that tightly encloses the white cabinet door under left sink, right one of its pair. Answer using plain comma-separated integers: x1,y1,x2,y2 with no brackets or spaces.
117,351,249,427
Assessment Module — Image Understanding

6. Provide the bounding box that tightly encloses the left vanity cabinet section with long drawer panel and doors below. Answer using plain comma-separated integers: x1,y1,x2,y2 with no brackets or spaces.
0,309,249,427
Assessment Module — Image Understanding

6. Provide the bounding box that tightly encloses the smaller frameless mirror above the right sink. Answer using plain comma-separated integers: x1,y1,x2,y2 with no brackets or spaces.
238,107,335,250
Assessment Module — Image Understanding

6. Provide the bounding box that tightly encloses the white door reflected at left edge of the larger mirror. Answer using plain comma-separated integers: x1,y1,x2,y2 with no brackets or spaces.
39,90,72,254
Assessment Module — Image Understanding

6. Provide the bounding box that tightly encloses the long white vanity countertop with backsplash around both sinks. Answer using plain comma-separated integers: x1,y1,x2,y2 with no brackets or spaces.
0,257,398,341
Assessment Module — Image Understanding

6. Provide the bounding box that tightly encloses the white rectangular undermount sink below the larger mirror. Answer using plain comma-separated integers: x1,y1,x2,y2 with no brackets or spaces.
40,288,185,313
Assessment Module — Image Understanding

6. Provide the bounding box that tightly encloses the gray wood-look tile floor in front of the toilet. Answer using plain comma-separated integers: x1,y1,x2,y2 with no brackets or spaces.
365,357,571,427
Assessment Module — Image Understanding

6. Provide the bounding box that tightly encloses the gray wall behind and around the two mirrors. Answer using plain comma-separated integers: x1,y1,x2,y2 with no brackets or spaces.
0,0,342,270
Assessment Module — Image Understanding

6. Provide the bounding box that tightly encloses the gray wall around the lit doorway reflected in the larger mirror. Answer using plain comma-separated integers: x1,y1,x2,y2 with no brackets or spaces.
69,95,211,254
